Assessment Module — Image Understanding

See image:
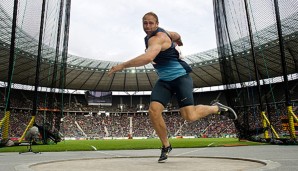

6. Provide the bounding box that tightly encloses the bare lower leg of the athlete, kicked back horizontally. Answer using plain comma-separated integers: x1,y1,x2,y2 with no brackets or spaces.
180,105,219,121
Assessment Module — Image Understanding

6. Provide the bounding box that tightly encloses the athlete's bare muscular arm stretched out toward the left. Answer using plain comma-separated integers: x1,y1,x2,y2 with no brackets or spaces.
108,36,163,76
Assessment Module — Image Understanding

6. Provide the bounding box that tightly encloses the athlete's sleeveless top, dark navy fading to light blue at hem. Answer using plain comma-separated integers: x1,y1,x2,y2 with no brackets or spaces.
145,27,192,81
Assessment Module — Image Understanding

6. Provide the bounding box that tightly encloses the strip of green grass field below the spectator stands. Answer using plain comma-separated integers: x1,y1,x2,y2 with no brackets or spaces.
0,138,262,152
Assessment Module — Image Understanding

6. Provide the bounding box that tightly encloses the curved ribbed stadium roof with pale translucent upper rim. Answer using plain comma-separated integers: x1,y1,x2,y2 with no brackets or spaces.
0,5,298,91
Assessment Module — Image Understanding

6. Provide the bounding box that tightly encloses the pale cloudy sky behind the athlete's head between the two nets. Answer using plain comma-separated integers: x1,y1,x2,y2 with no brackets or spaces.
68,0,216,62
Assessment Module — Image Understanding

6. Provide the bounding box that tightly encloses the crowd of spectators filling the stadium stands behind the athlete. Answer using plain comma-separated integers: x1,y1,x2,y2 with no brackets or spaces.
0,87,297,139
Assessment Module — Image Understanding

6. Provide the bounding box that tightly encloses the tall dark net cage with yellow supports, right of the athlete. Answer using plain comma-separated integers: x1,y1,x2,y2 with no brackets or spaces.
213,0,298,141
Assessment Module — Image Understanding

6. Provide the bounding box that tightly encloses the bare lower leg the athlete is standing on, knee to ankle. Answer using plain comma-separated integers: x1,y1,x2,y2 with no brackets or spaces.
149,102,170,147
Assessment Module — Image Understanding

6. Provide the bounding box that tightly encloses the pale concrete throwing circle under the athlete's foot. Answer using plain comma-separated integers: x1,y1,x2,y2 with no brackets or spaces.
30,156,266,171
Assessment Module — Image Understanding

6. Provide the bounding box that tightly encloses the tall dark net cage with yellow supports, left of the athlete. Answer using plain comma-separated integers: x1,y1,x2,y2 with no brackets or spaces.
0,0,70,143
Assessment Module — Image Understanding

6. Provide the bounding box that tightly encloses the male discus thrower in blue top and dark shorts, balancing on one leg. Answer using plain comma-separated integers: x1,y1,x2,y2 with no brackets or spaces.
108,12,237,163
